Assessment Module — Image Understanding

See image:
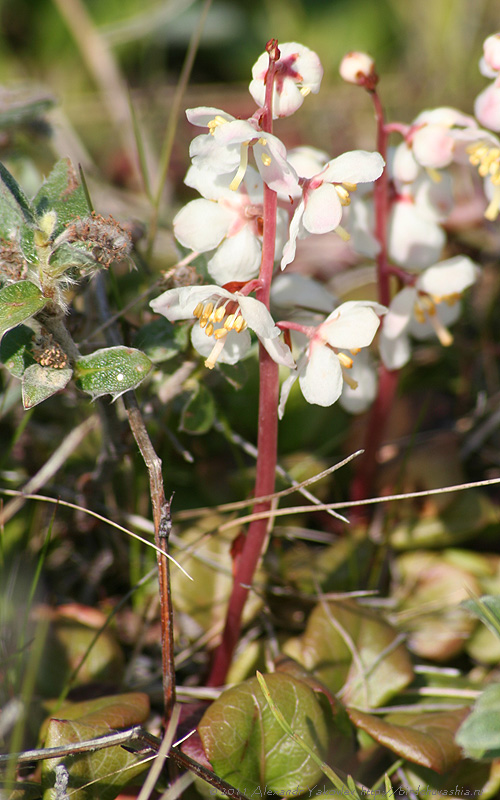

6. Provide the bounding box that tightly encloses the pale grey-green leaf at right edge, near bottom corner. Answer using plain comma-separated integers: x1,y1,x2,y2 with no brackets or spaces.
456,683,500,759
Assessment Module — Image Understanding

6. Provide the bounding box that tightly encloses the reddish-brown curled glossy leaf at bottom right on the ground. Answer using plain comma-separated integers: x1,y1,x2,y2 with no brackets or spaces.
348,708,469,773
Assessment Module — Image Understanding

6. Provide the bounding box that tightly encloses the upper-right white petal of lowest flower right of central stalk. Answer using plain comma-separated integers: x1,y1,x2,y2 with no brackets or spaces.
316,304,385,350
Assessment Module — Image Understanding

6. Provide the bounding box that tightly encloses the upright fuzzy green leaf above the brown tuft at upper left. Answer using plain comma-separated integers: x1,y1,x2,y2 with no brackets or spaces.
33,158,89,231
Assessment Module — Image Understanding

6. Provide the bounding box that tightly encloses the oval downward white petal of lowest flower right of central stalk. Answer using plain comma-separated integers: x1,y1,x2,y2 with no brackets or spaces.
299,342,343,406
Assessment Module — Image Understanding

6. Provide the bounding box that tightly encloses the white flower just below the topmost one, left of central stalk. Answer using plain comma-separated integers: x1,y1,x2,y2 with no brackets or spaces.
186,106,298,194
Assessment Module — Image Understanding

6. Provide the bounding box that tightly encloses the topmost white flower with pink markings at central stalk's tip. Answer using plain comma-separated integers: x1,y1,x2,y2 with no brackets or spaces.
249,42,323,119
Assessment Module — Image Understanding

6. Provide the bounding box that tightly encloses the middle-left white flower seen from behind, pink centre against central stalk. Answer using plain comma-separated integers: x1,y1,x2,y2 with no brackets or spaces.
173,166,287,285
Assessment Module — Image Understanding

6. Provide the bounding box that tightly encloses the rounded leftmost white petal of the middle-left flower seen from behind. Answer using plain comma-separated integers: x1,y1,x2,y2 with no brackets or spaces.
173,199,235,253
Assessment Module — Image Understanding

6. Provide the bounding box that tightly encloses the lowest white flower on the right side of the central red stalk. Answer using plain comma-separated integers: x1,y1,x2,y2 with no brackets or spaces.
279,301,386,418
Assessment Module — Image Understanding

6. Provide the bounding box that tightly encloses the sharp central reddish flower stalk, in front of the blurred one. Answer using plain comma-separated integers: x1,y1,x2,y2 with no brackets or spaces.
207,39,280,686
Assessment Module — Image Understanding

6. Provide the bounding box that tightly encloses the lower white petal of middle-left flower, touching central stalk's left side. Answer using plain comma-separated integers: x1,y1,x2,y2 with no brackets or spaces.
207,226,262,285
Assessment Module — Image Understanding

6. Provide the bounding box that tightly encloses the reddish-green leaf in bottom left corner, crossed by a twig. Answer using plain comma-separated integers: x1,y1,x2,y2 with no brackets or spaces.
42,692,150,800
